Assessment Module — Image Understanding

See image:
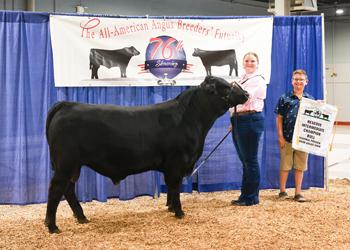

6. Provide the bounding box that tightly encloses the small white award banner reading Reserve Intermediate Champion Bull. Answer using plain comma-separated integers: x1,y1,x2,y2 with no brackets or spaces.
292,98,338,157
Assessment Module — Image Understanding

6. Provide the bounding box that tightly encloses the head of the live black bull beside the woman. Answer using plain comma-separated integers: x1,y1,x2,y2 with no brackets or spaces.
201,76,249,107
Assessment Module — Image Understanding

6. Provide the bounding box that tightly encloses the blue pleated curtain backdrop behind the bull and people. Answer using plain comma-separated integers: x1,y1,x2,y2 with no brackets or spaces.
0,11,324,205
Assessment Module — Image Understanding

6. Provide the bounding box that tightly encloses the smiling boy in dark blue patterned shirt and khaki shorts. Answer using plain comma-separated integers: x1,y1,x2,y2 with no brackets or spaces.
274,70,315,202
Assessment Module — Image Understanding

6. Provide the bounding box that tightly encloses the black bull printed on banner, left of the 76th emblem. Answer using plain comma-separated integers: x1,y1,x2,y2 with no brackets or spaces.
90,46,140,79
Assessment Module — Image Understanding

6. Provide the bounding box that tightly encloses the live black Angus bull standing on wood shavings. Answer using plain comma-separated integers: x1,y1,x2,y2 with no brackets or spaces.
45,76,248,233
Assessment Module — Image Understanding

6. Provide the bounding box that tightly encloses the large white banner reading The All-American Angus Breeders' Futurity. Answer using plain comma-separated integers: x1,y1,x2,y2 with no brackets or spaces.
50,15,273,87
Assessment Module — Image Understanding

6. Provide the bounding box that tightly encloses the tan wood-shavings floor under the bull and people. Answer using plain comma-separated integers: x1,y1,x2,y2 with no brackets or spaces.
0,179,350,250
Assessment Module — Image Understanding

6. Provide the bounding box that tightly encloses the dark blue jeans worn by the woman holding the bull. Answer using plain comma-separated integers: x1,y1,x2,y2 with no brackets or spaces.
231,113,265,205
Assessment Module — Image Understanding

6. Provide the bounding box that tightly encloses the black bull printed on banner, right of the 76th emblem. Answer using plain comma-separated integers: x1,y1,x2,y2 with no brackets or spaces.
192,48,238,76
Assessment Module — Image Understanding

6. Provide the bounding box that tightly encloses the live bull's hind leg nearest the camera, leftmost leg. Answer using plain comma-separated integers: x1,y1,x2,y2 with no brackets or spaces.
45,172,70,233
